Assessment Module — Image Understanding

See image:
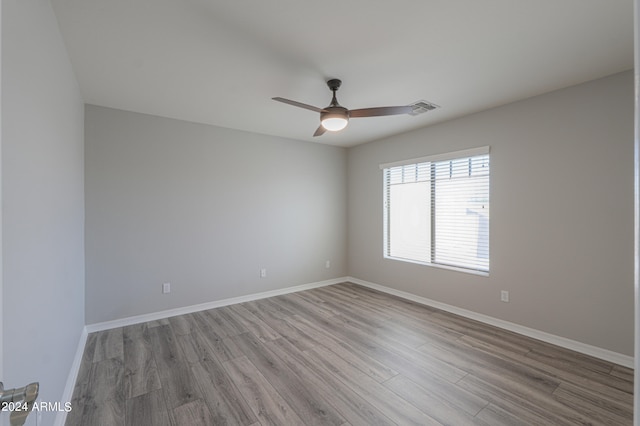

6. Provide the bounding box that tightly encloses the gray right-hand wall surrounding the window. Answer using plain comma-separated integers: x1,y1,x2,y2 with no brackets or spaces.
348,72,634,355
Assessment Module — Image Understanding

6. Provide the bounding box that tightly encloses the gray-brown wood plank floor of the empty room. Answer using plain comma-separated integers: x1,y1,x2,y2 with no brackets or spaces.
66,283,633,426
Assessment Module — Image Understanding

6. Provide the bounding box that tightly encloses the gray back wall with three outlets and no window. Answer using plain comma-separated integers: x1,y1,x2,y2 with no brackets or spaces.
85,105,347,324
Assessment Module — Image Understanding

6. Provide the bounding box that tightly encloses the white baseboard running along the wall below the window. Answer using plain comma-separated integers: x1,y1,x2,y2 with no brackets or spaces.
346,277,634,368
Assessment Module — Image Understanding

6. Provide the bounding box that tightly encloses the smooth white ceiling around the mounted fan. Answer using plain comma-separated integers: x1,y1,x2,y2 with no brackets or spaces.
52,0,633,146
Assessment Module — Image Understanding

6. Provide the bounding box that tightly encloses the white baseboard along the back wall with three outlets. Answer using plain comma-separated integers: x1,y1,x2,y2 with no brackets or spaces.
86,277,348,333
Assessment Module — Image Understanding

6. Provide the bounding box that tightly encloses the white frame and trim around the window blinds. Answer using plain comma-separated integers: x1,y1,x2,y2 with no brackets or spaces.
380,146,491,276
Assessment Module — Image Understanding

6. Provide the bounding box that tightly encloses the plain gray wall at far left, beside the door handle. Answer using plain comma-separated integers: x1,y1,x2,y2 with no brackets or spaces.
0,0,84,424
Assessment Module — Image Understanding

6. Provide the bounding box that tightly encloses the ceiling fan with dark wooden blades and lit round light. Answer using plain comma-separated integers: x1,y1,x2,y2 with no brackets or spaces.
272,78,413,136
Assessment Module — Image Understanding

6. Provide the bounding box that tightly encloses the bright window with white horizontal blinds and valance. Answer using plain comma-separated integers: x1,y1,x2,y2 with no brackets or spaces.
380,147,489,273
